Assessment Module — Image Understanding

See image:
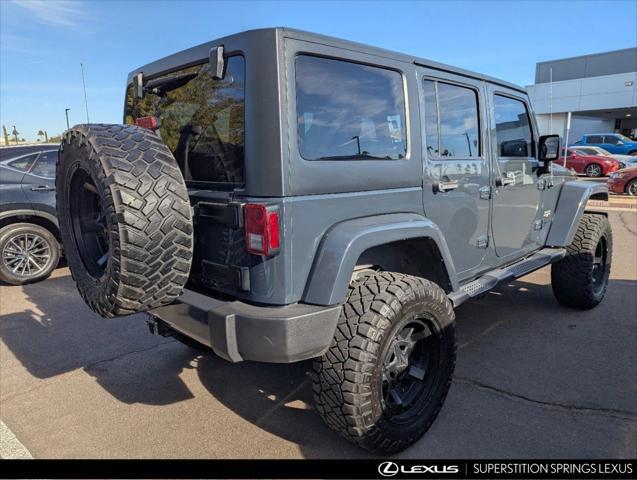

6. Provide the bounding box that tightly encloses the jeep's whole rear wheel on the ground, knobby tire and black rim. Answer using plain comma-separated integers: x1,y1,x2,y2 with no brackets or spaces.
312,272,456,453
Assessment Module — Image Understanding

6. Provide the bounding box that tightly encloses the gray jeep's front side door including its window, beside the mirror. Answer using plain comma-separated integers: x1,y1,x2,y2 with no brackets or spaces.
488,85,546,257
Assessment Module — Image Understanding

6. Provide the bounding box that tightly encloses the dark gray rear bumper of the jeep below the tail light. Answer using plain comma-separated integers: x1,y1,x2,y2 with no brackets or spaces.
148,290,342,363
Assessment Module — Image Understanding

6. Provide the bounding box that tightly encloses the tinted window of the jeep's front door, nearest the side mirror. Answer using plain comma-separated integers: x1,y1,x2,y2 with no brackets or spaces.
493,95,533,157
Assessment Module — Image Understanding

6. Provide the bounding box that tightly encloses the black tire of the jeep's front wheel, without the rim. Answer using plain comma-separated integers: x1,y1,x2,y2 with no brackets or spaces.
551,213,613,309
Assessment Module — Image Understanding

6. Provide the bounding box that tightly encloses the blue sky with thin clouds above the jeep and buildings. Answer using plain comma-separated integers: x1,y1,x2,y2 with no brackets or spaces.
0,0,637,140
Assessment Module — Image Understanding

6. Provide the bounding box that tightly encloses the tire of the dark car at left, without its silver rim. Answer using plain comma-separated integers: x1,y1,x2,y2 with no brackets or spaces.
0,223,60,285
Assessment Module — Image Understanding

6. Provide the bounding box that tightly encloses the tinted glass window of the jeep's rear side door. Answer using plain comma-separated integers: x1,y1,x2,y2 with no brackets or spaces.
424,80,480,158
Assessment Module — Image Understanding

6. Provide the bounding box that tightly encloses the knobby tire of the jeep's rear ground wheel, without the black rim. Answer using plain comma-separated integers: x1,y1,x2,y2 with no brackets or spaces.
312,272,456,454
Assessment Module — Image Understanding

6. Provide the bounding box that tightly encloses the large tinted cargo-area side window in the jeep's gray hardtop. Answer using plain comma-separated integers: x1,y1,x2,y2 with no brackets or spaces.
296,55,407,160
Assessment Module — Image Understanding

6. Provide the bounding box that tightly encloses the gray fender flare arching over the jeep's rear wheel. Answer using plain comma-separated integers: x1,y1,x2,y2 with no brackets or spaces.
303,213,458,305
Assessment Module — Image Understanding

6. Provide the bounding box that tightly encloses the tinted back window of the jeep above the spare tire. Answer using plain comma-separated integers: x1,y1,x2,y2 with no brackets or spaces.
126,56,245,184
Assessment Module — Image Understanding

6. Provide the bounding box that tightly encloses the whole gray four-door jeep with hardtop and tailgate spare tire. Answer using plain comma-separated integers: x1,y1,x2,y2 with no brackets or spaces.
57,28,612,453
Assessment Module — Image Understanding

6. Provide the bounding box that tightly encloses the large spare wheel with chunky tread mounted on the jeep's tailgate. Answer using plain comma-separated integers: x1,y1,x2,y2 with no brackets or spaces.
56,124,193,317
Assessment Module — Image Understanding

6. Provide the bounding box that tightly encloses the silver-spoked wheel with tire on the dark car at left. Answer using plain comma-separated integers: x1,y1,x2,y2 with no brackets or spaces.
0,223,60,285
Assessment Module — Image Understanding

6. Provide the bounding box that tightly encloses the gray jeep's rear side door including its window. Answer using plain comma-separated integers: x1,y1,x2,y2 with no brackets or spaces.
419,68,489,279
